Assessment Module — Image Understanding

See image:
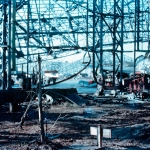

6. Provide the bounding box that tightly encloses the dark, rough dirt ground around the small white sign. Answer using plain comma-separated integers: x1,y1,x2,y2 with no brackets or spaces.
0,95,150,150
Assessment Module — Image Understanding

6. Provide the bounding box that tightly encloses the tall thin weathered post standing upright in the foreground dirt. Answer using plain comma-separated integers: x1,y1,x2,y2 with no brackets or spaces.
38,56,44,143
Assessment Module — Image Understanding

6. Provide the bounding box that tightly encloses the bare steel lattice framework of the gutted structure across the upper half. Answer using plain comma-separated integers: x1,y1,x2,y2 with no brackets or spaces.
0,0,150,88
